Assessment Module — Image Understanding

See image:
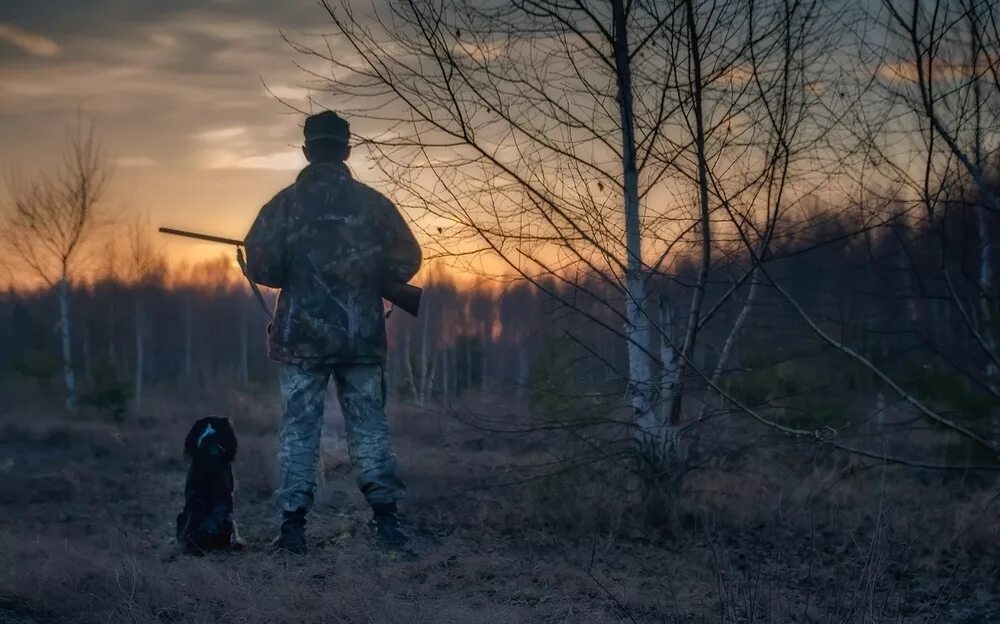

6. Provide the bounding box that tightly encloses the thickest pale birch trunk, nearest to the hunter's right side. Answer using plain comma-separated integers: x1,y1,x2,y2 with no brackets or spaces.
612,0,664,471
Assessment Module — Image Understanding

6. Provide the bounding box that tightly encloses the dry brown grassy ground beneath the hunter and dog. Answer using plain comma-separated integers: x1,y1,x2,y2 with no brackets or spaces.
0,395,1000,624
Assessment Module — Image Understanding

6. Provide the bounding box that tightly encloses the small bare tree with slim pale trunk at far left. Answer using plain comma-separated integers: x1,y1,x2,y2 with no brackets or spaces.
0,121,111,411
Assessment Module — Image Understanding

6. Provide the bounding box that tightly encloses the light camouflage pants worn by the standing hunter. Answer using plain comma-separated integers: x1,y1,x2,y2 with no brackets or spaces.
275,364,405,511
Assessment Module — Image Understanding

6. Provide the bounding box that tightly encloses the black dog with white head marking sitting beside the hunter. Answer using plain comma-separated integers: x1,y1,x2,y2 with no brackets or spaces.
177,418,243,554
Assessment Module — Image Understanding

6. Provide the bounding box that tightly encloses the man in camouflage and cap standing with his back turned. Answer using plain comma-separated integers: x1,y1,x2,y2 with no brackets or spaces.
245,111,421,554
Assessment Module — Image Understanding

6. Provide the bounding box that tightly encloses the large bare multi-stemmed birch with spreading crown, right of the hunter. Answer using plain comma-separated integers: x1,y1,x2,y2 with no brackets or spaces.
304,0,836,492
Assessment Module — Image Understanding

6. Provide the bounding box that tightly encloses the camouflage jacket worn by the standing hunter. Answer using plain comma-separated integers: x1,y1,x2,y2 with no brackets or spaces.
245,163,421,366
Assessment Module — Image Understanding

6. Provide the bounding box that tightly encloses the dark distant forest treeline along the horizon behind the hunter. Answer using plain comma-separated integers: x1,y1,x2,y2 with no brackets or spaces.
0,199,998,438
